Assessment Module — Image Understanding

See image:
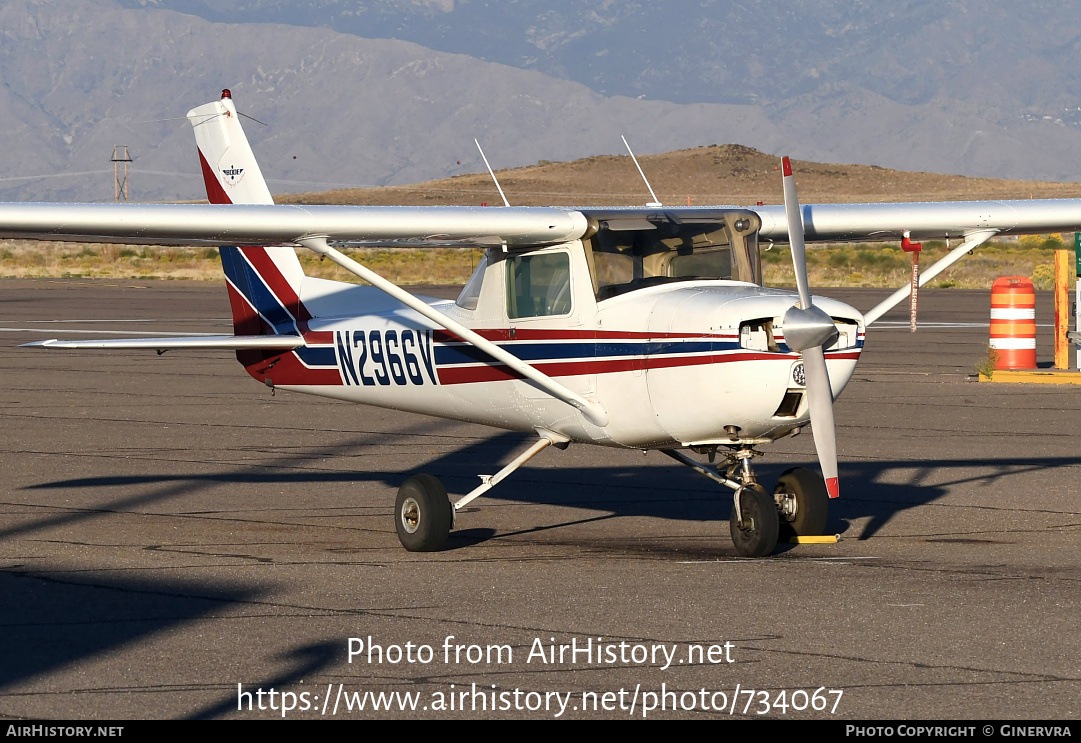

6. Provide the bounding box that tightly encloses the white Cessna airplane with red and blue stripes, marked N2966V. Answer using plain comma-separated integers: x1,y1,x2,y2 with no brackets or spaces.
0,91,1081,556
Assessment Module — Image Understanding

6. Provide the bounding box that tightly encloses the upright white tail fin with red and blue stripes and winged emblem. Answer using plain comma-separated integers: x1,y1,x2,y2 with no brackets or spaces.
188,90,310,335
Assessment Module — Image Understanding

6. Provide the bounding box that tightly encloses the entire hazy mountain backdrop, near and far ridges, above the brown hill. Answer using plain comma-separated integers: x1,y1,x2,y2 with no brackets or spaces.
0,0,1081,200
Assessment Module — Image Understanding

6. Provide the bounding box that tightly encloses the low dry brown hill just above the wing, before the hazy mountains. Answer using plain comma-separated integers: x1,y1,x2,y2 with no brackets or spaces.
280,145,1081,207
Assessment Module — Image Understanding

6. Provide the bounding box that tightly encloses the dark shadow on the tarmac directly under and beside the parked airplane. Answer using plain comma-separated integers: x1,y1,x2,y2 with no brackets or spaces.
16,433,1081,548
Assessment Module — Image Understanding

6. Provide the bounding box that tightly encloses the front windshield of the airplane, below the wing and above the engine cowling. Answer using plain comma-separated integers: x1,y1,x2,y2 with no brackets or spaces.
589,220,733,300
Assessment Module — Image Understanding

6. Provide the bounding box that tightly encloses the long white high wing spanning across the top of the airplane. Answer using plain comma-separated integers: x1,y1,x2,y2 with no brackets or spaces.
0,199,1081,249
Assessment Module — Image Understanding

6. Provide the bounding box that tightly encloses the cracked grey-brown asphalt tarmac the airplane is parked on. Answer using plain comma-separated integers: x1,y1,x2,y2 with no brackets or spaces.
0,280,1081,720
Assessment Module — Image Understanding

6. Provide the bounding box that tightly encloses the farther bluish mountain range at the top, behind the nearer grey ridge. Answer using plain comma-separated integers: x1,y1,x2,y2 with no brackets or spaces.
125,0,1081,117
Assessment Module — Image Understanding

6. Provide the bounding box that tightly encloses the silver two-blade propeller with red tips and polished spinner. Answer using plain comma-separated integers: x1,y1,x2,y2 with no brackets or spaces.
782,157,840,497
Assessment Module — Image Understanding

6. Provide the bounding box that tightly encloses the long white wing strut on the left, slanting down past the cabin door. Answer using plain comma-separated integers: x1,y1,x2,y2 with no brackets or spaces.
297,236,609,427
